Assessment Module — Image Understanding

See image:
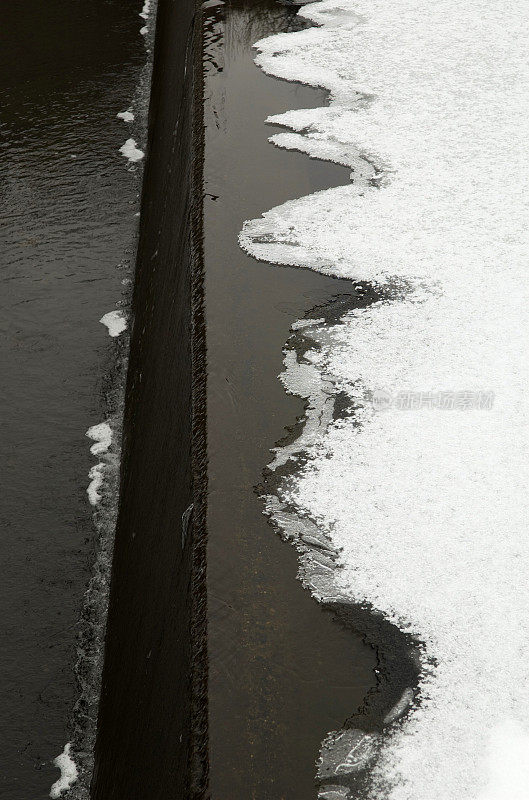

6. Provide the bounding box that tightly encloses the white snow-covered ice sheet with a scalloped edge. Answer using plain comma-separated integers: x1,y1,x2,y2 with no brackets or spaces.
241,0,529,800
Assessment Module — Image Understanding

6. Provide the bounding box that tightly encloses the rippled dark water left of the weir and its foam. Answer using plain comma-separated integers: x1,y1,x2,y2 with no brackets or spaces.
0,6,145,800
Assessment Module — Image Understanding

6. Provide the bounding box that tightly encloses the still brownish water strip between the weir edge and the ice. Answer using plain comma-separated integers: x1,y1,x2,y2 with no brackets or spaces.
205,0,375,800
